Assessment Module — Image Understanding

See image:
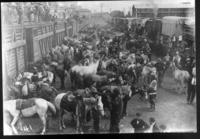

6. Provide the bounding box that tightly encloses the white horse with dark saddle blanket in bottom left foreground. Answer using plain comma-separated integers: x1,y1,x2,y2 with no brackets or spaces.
4,98,56,134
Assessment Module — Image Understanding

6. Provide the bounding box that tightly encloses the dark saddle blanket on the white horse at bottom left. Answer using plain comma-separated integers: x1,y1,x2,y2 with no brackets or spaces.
16,98,35,110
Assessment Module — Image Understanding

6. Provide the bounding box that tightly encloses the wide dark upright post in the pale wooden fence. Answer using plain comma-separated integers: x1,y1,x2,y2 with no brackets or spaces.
25,27,34,68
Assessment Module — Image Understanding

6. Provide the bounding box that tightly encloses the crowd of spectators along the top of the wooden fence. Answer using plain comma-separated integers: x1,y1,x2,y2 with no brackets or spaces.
2,3,64,25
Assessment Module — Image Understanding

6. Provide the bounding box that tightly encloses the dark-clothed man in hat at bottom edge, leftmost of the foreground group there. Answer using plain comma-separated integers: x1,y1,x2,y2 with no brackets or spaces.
130,113,149,133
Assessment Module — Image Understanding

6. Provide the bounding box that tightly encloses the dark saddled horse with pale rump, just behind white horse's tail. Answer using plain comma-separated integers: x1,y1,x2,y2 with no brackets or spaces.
55,90,104,133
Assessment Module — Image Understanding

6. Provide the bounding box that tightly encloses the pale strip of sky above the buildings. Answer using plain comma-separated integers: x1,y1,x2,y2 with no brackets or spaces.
74,0,195,13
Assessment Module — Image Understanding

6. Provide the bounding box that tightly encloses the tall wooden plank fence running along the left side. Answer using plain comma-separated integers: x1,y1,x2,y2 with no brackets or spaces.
2,19,88,77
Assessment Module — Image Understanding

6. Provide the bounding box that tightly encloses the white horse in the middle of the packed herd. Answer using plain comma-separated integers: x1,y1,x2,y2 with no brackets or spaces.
71,60,99,76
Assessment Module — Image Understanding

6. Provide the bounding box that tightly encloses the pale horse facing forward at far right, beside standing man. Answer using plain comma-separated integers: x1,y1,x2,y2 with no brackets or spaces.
171,62,190,94
